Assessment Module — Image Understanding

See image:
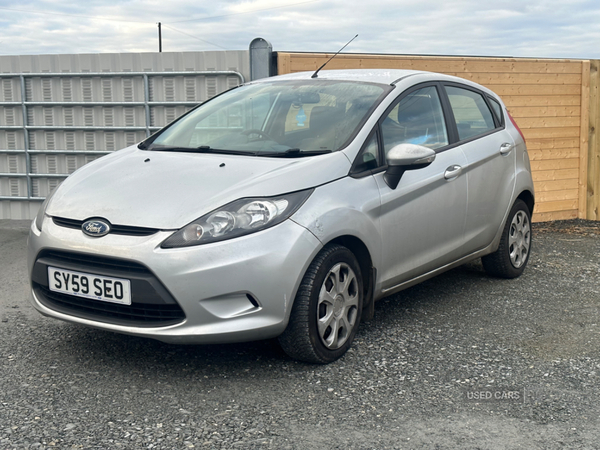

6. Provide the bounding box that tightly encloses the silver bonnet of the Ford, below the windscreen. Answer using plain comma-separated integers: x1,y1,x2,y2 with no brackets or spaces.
46,147,350,230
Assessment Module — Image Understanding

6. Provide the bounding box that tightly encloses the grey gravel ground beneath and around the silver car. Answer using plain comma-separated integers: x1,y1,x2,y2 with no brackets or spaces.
0,220,600,449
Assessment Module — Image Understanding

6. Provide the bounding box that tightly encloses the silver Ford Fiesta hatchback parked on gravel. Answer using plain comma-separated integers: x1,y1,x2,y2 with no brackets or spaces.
28,70,534,363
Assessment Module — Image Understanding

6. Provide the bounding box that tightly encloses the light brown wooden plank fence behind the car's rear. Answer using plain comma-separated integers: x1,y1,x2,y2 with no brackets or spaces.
277,52,600,222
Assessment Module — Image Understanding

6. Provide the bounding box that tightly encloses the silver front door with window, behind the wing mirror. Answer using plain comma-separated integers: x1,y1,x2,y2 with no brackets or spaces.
374,83,467,291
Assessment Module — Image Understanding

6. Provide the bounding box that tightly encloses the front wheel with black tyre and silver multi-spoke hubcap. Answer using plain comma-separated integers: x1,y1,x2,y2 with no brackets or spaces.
279,244,363,364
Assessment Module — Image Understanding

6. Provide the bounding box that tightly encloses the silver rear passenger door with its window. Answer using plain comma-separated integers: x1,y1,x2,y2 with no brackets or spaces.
444,83,516,252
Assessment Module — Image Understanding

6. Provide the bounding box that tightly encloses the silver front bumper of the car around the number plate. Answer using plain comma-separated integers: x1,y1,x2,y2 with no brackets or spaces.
28,217,321,343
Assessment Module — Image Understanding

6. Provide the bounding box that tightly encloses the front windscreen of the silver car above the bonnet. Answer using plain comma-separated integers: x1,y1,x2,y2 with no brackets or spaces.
142,79,392,157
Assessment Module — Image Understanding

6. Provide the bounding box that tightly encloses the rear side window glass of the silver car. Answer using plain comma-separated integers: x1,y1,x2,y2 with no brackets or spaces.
446,86,496,140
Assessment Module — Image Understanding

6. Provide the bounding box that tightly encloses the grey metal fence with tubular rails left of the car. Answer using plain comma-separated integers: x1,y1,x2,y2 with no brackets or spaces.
0,51,249,219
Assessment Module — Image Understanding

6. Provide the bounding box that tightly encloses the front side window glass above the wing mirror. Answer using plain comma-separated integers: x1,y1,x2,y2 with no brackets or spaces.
381,86,448,155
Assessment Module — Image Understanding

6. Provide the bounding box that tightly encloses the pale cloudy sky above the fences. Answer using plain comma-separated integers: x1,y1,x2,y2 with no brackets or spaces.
0,0,600,59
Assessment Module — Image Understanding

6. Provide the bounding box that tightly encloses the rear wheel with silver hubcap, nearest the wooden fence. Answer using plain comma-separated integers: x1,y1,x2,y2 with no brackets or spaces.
481,200,532,278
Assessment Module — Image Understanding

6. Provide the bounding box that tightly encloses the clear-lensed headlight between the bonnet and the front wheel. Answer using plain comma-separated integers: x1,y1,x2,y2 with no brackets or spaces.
162,189,314,248
